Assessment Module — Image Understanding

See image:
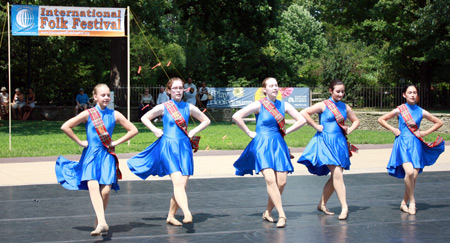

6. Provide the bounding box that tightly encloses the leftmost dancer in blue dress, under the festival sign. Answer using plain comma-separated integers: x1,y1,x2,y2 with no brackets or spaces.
55,84,138,236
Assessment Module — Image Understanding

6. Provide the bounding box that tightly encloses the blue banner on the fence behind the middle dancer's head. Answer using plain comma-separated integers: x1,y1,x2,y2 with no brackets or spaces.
208,87,309,108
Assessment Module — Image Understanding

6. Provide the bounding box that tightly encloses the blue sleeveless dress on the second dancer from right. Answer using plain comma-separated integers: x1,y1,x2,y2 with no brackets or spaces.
297,98,350,176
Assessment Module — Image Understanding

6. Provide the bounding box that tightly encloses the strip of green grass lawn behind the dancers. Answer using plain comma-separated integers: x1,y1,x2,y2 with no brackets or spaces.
0,121,450,158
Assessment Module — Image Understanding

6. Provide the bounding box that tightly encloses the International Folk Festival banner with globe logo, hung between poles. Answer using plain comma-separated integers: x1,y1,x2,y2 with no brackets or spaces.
11,5,126,37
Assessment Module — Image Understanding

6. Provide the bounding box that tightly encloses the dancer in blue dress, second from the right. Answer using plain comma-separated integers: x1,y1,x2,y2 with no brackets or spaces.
298,79,359,219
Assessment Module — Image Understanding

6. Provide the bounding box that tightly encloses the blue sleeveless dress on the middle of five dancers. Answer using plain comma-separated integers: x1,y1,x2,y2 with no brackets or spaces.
234,100,294,176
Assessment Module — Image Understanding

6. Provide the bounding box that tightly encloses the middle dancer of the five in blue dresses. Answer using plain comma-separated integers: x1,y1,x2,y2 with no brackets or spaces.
233,77,306,228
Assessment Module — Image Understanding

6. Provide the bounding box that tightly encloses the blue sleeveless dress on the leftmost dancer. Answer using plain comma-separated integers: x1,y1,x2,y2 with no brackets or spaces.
55,105,120,191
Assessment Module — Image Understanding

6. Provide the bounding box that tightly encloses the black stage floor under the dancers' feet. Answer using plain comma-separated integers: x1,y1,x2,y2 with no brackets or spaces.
0,172,450,243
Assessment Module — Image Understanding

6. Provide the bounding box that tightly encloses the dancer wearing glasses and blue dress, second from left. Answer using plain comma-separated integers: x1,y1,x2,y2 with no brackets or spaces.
128,78,211,226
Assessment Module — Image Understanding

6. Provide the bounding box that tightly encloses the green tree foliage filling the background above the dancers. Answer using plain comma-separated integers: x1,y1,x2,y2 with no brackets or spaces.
0,0,450,104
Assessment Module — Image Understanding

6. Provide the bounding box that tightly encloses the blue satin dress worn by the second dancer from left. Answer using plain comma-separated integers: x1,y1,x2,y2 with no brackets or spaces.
128,99,194,180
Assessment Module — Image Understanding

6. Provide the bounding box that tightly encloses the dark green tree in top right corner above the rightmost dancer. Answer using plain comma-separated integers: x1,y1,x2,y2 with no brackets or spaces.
363,0,450,103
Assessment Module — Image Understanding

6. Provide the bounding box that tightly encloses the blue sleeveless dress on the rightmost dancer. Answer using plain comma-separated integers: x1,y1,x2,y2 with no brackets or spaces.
387,103,445,178
